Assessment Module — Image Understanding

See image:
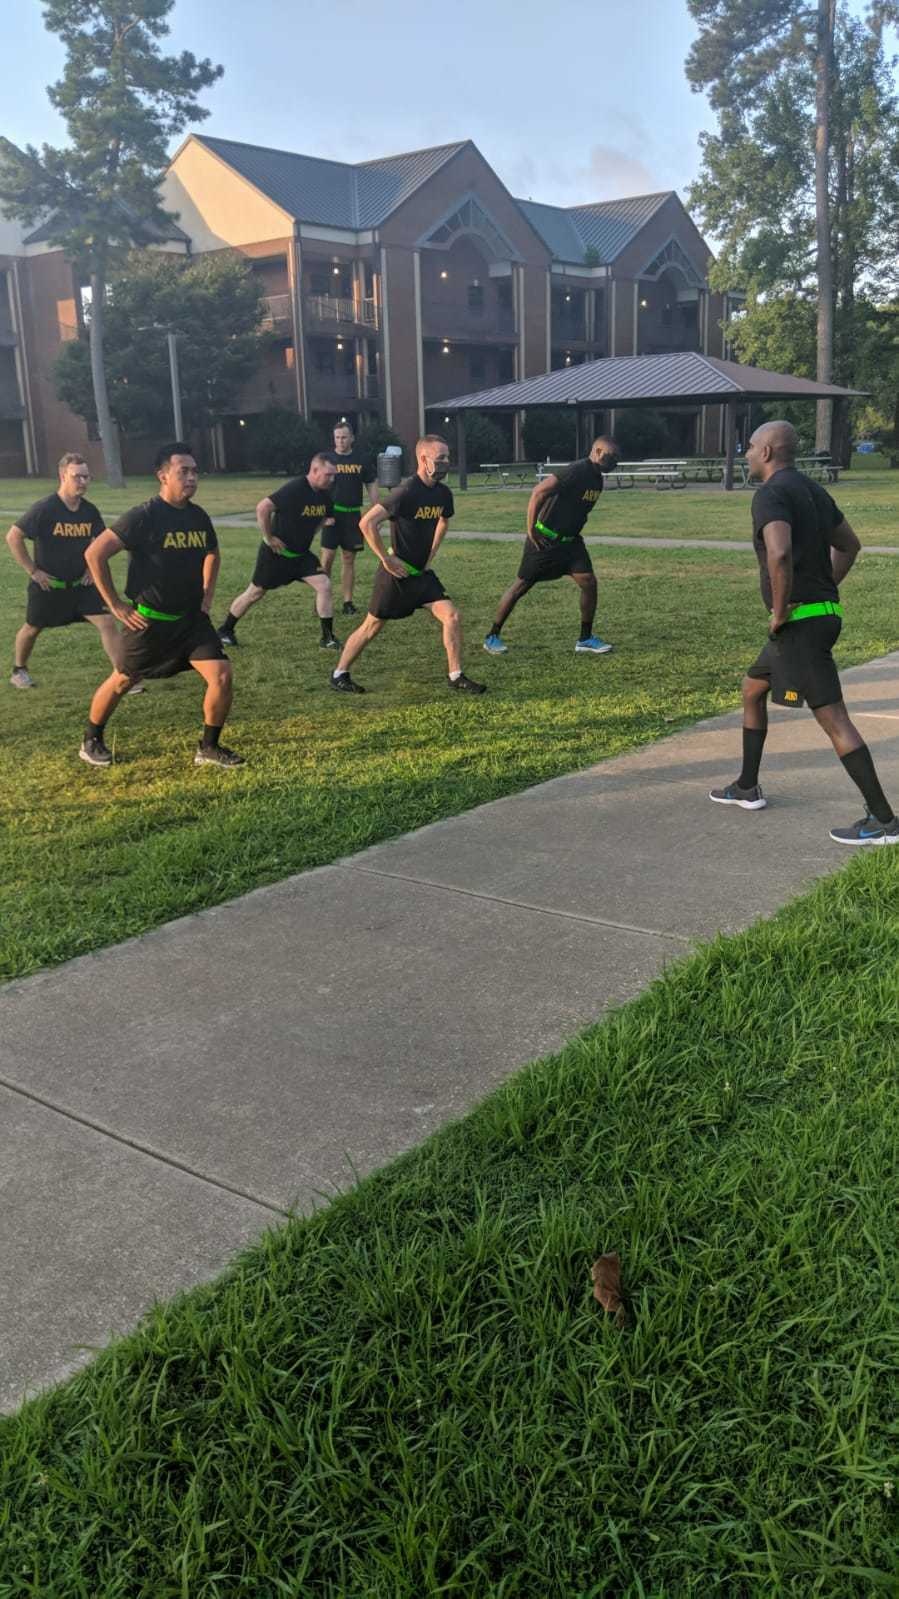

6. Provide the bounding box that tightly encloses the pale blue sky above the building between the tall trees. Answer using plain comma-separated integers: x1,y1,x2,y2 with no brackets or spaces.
0,0,713,205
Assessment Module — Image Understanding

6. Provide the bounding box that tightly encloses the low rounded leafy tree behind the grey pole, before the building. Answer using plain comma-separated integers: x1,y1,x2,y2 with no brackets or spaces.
56,253,269,435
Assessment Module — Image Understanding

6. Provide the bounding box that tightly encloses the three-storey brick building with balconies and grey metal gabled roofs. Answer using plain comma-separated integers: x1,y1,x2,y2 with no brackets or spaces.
0,134,726,470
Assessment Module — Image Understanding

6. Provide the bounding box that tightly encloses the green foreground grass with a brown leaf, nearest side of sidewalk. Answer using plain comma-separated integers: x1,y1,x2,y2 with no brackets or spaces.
0,851,899,1599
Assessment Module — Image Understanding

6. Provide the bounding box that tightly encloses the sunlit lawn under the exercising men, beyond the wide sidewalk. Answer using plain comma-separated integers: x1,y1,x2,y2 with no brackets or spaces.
0,529,899,977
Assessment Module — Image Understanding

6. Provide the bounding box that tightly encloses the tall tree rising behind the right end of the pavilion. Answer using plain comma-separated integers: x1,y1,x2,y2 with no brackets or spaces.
686,0,899,448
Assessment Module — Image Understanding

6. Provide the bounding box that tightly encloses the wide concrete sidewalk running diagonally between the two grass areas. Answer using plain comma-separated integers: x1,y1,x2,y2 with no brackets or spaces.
0,654,899,1409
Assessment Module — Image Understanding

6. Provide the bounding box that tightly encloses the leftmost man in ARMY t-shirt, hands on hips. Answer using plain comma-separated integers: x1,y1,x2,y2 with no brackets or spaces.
6,451,120,689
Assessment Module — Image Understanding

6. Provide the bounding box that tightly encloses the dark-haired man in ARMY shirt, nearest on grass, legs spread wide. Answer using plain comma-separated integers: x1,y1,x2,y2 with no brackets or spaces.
78,441,243,766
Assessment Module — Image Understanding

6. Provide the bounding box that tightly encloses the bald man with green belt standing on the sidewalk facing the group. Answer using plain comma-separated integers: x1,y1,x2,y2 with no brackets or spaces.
709,422,899,844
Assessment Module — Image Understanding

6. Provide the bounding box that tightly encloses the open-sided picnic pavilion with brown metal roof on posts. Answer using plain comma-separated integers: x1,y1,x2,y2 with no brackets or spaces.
440,350,861,489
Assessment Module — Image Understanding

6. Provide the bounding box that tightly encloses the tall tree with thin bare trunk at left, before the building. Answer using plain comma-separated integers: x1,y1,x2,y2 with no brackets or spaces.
0,0,222,488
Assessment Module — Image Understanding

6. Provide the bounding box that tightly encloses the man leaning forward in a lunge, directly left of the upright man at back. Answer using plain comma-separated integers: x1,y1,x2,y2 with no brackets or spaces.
219,454,341,649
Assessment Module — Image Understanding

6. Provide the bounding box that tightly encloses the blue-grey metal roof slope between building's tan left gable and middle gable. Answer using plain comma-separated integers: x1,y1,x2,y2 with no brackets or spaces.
194,133,467,230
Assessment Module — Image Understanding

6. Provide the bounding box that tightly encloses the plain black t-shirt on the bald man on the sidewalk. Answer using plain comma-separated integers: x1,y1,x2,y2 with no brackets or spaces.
752,467,843,609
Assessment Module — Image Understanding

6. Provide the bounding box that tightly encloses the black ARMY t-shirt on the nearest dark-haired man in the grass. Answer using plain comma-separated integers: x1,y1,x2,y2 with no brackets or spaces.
112,494,219,614
